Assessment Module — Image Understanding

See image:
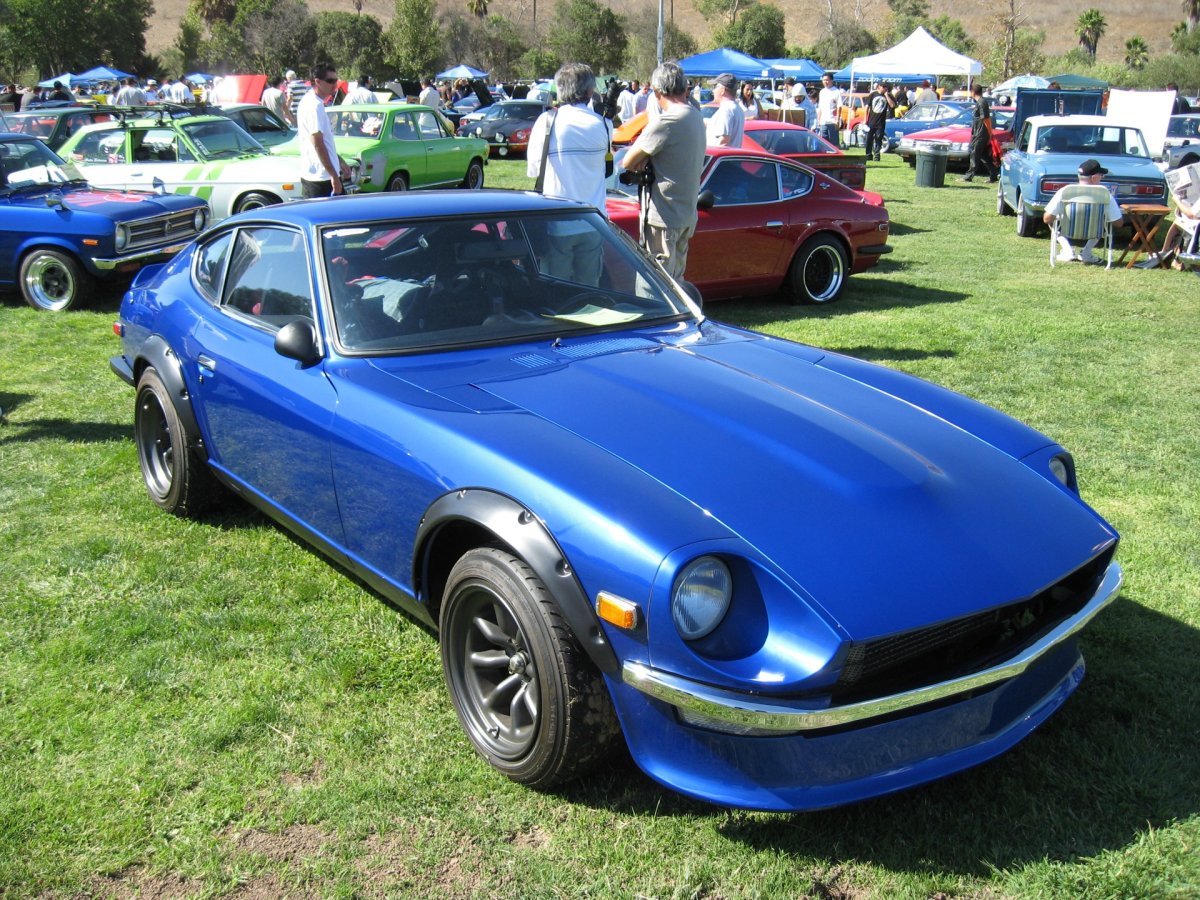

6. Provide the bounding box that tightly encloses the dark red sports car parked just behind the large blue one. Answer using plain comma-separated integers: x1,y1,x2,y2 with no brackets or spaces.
607,148,892,304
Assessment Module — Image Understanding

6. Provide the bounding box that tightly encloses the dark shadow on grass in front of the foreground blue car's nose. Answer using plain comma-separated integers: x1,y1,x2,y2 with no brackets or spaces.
564,594,1200,877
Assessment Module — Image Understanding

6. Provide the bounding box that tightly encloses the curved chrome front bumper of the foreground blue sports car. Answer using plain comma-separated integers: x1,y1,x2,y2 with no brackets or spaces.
622,562,1124,733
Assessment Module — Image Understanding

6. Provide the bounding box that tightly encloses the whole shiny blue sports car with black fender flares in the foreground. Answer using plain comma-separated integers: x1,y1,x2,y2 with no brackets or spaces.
112,191,1121,810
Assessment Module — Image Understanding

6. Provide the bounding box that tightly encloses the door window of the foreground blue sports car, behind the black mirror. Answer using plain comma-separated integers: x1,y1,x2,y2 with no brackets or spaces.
222,227,314,331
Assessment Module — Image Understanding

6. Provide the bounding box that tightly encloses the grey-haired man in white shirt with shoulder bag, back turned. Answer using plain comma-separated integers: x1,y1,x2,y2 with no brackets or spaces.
526,62,612,287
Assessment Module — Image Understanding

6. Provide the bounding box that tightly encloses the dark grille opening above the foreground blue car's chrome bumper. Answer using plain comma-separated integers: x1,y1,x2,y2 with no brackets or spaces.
832,548,1114,704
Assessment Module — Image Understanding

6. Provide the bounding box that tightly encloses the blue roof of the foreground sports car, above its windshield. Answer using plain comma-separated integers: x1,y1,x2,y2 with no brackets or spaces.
226,188,590,228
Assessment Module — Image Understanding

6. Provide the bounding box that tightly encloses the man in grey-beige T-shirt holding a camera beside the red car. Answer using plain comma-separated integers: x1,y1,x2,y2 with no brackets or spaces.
623,62,704,280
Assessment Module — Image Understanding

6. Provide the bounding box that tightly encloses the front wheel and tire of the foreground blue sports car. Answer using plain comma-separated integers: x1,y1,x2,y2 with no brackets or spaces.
440,548,620,787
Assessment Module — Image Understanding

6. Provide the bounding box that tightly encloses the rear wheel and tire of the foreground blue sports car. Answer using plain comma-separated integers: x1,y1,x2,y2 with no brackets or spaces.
133,367,222,517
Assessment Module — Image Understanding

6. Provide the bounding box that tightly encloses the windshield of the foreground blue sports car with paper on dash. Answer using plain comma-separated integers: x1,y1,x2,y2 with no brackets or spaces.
322,210,690,353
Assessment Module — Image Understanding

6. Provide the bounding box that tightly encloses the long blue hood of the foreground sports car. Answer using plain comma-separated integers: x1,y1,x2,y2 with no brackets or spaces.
381,332,1116,638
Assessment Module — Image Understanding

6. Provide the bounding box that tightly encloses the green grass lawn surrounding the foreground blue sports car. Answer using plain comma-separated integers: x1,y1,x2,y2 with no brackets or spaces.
0,158,1200,900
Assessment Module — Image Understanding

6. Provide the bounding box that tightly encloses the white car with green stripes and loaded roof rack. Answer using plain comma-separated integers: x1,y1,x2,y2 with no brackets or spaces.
60,113,301,221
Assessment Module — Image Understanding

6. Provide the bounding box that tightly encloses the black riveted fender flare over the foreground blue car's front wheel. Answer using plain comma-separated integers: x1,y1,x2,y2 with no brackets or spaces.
413,487,619,674
